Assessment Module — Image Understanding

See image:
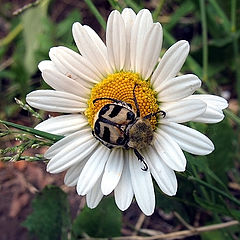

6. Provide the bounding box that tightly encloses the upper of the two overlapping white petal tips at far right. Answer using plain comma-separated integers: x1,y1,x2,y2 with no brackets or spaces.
188,94,228,110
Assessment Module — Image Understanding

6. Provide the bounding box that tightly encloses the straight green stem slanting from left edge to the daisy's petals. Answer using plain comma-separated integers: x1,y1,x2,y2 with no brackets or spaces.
0,120,64,142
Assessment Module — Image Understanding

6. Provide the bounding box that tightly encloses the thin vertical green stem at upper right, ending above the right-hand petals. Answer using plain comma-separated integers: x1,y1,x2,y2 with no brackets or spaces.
200,0,208,82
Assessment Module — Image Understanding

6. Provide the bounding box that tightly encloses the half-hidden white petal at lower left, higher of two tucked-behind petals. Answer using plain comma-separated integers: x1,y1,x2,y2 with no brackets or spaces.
64,161,86,187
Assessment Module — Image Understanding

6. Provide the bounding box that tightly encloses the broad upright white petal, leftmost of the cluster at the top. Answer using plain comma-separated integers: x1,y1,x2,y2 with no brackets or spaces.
106,10,127,71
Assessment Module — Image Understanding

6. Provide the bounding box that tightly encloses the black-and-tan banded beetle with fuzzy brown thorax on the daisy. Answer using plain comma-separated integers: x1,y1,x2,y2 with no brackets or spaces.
92,84,166,171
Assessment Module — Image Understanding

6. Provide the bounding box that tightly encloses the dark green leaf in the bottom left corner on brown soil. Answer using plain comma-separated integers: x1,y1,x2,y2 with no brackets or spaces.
23,186,70,240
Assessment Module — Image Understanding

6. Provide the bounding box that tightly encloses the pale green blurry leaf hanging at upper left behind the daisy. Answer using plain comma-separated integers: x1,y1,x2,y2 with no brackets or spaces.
21,0,49,74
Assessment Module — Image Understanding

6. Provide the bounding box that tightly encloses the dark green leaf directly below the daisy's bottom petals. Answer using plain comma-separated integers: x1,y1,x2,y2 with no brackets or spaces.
72,197,122,239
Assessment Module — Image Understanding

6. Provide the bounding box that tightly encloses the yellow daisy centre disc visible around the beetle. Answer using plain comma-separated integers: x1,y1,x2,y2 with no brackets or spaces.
85,72,159,129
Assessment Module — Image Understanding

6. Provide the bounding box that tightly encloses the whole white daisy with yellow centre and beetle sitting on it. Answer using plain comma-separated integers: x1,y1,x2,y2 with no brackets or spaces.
26,8,228,215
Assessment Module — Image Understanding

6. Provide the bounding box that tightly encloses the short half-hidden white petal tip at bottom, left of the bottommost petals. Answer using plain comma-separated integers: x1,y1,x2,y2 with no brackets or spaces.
86,178,103,209
